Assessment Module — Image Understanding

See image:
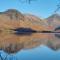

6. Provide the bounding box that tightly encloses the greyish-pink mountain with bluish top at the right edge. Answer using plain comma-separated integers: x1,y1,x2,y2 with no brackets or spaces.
47,14,60,30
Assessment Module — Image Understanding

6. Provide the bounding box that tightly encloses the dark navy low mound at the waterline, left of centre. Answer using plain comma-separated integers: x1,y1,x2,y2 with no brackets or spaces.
12,28,37,35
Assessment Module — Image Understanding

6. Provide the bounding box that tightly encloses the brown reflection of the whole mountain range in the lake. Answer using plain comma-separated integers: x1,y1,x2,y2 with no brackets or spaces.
0,33,60,53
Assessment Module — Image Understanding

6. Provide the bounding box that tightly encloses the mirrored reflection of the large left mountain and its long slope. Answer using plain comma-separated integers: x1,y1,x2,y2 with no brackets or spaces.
0,33,48,53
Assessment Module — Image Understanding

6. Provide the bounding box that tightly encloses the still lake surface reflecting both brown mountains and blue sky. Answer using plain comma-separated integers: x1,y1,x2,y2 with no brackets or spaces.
0,33,60,60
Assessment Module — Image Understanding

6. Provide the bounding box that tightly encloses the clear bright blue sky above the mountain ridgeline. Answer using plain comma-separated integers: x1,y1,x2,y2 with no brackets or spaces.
0,0,58,18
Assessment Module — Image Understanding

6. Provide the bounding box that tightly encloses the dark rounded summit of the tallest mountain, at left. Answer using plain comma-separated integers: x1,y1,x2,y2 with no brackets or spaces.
3,9,24,20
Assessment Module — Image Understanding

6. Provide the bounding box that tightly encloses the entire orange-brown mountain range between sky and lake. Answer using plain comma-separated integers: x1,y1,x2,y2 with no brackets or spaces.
0,9,60,31
